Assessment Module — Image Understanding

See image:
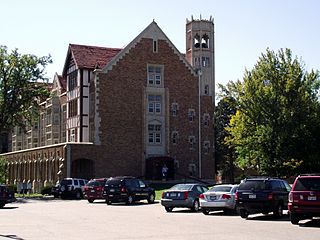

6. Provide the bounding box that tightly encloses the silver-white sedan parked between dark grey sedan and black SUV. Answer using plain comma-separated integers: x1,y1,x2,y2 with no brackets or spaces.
199,184,239,215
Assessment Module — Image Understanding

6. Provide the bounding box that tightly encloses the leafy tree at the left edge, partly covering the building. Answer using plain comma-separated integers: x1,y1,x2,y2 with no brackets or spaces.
0,46,52,150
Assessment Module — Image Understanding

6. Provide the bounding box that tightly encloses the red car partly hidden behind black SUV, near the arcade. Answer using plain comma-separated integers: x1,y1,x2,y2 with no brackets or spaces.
83,178,107,203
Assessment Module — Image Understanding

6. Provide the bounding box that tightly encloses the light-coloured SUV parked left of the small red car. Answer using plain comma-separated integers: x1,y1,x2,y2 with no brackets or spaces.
52,178,88,199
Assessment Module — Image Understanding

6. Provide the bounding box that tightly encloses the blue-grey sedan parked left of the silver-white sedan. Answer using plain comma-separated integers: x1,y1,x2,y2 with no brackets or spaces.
161,183,208,212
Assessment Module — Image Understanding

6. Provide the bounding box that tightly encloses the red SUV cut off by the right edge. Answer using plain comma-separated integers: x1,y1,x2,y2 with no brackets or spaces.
288,174,320,224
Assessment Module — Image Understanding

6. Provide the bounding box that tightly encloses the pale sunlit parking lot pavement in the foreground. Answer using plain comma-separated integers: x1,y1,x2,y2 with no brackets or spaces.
0,200,320,240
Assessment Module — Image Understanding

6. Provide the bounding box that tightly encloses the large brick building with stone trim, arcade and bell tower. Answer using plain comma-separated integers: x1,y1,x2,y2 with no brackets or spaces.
4,18,215,191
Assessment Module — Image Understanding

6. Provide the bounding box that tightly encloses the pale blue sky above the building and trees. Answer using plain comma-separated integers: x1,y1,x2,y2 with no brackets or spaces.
0,0,320,88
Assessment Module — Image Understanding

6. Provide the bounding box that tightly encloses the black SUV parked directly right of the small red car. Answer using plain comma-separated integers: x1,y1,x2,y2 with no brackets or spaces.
103,176,156,204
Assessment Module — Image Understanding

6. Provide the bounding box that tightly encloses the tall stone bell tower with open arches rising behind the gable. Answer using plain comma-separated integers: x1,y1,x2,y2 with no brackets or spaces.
186,15,215,100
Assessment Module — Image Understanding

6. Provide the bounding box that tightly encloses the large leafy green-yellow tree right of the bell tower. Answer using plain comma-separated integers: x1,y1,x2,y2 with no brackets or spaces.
227,49,320,176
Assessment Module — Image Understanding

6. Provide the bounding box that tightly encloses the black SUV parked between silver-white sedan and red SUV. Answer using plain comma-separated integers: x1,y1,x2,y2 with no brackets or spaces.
236,177,290,218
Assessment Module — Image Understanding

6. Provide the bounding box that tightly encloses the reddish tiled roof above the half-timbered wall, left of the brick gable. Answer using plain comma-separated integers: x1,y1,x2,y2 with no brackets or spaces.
62,44,122,75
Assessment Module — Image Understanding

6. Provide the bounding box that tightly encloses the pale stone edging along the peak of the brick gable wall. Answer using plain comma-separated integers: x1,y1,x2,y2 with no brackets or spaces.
102,21,196,75
